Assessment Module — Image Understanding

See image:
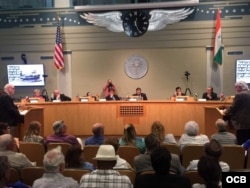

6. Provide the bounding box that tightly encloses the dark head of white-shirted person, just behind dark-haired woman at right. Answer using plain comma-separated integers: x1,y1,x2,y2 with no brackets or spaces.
204,139,222,160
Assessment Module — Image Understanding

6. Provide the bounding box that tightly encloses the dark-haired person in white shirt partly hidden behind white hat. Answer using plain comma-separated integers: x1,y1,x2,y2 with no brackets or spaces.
104,137,132,169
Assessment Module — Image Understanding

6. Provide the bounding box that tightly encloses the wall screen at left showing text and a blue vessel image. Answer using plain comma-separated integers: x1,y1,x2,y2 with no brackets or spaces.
7,64,45,86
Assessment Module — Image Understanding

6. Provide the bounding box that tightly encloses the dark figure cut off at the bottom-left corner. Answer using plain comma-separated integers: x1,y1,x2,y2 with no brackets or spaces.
0,156,29,188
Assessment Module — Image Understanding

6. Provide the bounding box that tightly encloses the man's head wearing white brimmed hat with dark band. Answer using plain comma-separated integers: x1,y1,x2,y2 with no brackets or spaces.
94,145,117,170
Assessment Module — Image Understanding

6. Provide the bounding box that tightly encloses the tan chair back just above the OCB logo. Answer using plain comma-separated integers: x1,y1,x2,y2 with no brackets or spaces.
220,145,245,170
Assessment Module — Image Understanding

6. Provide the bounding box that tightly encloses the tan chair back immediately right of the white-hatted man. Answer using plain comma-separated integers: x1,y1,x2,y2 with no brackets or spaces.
117,146,141,168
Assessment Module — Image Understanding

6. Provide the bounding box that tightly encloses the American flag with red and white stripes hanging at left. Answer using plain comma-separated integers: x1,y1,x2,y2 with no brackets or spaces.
54,20,64,70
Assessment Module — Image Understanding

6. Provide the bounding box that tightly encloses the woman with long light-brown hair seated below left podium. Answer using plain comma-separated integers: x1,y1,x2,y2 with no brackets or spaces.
23,121,44,144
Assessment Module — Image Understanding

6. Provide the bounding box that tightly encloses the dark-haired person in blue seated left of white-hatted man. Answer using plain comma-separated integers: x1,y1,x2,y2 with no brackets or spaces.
65,146,94,171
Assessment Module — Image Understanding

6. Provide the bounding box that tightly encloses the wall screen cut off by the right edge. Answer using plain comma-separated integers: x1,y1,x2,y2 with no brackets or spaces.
235,59,250,84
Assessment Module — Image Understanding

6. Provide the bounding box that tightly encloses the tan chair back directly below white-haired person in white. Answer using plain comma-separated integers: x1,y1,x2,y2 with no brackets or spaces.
181,144,205,168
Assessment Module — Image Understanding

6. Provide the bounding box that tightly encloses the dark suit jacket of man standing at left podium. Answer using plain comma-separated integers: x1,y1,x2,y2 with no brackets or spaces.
0,92,23,126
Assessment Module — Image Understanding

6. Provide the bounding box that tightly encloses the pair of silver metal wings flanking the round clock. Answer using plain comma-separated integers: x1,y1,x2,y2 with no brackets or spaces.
80,8,194,32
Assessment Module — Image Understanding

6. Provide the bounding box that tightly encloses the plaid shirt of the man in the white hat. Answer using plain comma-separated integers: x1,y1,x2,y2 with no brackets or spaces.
80,169,133,188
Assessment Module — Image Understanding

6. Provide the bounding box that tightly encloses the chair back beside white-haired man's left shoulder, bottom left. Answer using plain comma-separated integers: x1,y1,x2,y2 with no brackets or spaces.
20,167,44,186
